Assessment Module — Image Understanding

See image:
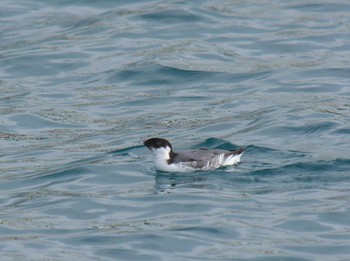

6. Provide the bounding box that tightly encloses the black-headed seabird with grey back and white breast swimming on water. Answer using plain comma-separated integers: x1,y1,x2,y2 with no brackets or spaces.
143,138,244,172
